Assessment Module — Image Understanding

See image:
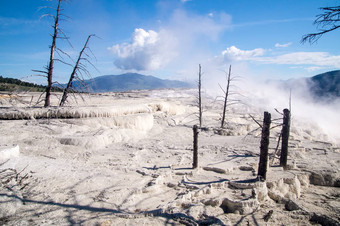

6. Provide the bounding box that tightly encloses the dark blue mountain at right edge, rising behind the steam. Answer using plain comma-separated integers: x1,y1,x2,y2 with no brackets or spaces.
307,70,340,98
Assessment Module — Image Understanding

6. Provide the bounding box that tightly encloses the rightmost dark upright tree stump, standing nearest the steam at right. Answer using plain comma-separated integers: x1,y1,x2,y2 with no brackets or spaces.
280,109,290,167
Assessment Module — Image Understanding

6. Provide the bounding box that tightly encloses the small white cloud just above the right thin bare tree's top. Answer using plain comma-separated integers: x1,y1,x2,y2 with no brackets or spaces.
222,46,265,61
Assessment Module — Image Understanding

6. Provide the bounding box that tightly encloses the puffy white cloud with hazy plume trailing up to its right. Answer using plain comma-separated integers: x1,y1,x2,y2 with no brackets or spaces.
108,9,231,71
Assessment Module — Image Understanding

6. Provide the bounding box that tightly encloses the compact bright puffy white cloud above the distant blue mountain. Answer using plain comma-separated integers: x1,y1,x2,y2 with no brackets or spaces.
108,28,176,71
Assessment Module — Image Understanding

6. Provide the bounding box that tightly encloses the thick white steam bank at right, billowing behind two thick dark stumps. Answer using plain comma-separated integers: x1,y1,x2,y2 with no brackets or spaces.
239,78,340,143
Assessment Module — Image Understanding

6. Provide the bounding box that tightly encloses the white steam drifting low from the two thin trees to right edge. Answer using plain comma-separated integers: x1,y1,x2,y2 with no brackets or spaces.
201,65,340,143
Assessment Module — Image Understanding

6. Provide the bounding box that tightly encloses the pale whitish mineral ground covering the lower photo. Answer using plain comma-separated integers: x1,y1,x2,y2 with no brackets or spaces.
0,90,340,225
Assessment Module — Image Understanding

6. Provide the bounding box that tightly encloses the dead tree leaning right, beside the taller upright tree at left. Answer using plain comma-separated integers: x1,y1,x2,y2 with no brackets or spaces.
59,34,94,107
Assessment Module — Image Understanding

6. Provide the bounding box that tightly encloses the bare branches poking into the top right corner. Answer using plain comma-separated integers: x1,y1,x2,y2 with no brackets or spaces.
301,6,340,43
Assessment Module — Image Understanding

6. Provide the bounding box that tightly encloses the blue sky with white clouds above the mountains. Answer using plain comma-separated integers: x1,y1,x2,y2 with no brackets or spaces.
0,0,340,83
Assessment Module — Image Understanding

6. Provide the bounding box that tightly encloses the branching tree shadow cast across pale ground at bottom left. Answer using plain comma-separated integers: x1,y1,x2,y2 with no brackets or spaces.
0,168,211,225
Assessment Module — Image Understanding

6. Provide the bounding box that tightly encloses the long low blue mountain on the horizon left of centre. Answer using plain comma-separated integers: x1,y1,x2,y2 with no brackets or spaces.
74,73,192,92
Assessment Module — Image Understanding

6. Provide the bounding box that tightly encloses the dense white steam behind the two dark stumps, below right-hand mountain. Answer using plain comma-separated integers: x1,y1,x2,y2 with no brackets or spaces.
248,80,340,142
